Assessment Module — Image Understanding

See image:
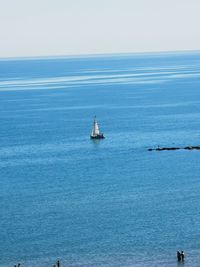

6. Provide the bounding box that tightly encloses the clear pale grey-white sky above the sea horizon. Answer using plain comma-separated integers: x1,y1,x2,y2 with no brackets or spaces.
0,0,200,57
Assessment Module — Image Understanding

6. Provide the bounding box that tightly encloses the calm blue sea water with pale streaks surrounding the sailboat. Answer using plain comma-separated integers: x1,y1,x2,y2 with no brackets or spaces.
0,52,200,267
